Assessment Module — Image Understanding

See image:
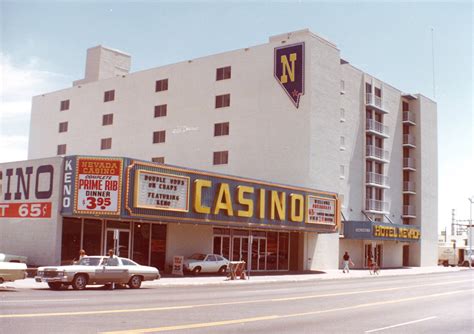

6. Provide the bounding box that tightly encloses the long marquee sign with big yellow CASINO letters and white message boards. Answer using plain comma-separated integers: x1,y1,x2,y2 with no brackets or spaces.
124,160,339,232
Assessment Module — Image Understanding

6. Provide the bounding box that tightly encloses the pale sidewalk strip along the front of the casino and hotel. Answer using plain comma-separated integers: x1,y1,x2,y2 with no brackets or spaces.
0,266,468,291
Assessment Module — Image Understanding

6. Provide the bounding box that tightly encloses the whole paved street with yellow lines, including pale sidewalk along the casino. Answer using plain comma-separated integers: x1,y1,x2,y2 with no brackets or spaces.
0,267,474,334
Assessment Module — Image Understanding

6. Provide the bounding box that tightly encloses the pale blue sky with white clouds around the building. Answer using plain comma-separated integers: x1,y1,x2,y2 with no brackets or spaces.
0,0,474,229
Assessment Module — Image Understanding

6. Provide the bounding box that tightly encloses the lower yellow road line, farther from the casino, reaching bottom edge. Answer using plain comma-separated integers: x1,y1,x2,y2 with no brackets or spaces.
101,289,466,334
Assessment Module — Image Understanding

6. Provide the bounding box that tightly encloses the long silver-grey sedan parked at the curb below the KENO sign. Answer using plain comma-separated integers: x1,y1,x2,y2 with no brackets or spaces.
35,256,160,290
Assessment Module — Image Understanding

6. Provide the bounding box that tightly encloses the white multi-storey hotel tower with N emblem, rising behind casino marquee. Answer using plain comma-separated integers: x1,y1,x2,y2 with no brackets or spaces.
18,30,437,269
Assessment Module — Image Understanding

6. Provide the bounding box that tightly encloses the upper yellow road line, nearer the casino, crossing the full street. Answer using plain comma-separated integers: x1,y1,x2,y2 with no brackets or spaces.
0,279,473,319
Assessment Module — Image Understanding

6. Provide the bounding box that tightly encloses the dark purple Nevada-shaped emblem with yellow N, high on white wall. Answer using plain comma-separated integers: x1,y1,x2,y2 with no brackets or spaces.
273,43,304,108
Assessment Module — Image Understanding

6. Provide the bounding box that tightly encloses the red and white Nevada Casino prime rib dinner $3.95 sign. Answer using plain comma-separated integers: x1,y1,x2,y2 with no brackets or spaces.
74,157,123,215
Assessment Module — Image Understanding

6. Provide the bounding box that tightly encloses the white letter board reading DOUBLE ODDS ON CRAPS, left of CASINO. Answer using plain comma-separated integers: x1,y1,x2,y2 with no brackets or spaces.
134,170,189,211
